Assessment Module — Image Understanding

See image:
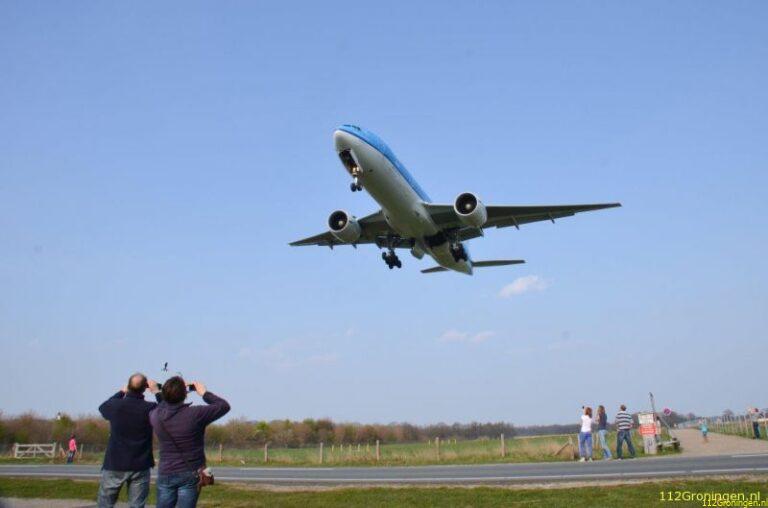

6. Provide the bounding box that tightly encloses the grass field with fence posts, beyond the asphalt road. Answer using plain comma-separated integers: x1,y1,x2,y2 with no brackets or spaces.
0,433,668,467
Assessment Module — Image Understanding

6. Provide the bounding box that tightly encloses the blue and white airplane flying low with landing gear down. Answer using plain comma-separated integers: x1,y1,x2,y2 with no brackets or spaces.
290,124,621,275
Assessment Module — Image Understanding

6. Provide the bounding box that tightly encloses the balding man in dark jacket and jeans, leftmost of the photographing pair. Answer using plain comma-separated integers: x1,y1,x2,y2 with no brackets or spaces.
99,373,161,508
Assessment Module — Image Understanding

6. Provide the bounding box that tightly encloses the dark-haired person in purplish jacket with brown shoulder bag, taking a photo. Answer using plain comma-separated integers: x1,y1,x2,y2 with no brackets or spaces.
149,376,229,508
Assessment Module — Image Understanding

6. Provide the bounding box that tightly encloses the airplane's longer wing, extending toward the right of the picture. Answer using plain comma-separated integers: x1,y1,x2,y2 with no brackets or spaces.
425,203,621,240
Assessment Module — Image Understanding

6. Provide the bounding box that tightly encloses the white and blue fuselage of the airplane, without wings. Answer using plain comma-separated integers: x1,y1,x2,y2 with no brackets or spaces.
333,130,472,274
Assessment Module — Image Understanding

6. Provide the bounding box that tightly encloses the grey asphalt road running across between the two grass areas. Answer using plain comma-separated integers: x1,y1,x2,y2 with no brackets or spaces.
0,454,768,485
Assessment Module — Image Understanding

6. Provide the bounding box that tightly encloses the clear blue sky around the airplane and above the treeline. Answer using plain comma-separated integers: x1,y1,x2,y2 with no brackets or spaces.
0,1,768,424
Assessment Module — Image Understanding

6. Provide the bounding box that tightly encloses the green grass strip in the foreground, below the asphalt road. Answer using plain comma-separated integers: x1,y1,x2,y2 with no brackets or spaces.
0,478,768,508
